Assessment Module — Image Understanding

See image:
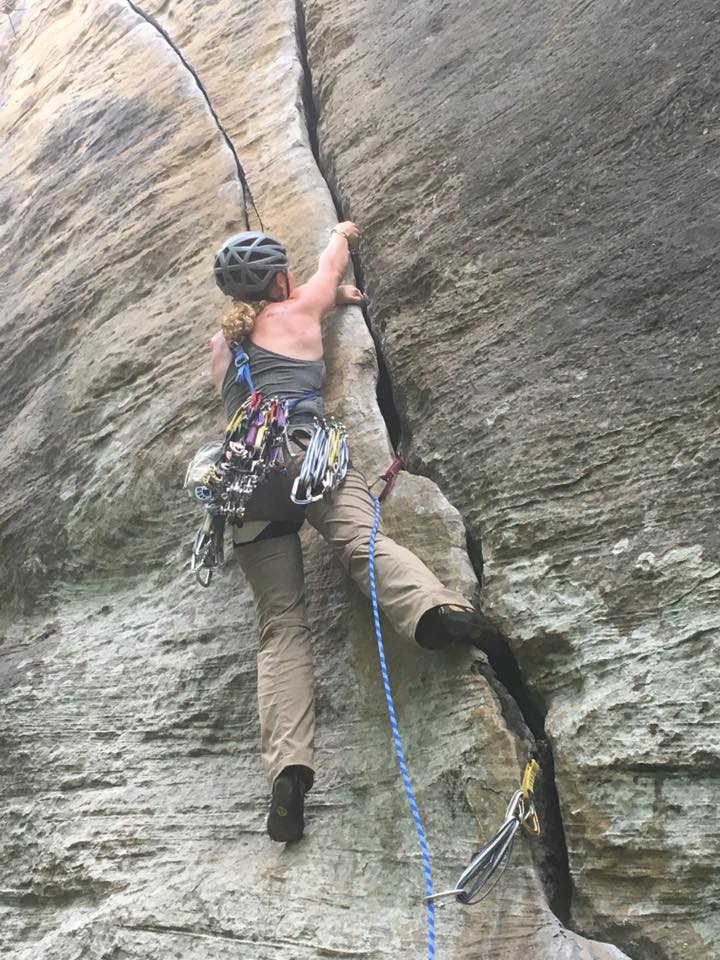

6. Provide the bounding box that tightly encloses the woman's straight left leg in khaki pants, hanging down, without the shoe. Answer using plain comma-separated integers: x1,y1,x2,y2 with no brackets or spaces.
235,533,315,788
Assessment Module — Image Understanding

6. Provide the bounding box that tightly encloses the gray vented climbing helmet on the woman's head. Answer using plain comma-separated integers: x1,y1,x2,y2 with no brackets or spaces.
215,230,290,300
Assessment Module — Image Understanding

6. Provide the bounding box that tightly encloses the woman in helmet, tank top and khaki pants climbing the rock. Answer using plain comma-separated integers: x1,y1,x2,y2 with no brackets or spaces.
205,221,502,842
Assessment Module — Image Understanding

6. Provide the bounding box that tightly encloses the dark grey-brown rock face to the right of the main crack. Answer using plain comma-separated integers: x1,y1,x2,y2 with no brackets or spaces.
306,0,720,960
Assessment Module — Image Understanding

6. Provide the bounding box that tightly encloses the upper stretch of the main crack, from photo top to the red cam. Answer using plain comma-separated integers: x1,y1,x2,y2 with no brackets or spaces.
295,0,402,452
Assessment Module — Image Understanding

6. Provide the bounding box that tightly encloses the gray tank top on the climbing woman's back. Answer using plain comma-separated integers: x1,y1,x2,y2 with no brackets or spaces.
222,337,325,423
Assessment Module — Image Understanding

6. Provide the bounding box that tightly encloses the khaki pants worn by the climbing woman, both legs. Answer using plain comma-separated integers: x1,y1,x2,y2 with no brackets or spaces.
236,467,467,783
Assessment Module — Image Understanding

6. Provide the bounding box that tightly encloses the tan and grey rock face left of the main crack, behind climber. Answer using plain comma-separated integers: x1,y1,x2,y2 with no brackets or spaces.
0,0,621,960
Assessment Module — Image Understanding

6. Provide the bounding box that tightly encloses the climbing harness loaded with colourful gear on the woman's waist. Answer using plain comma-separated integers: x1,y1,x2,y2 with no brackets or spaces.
184,344,349,587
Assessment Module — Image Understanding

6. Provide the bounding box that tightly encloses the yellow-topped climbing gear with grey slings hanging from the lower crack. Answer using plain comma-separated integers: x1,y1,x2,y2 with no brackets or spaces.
425,757,540,904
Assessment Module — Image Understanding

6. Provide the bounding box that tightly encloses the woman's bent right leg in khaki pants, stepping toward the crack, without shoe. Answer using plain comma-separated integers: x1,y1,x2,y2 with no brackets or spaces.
306,467,469,645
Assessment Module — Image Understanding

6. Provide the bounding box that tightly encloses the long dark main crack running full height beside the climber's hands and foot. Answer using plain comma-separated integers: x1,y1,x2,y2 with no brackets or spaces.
295,0,572,926
